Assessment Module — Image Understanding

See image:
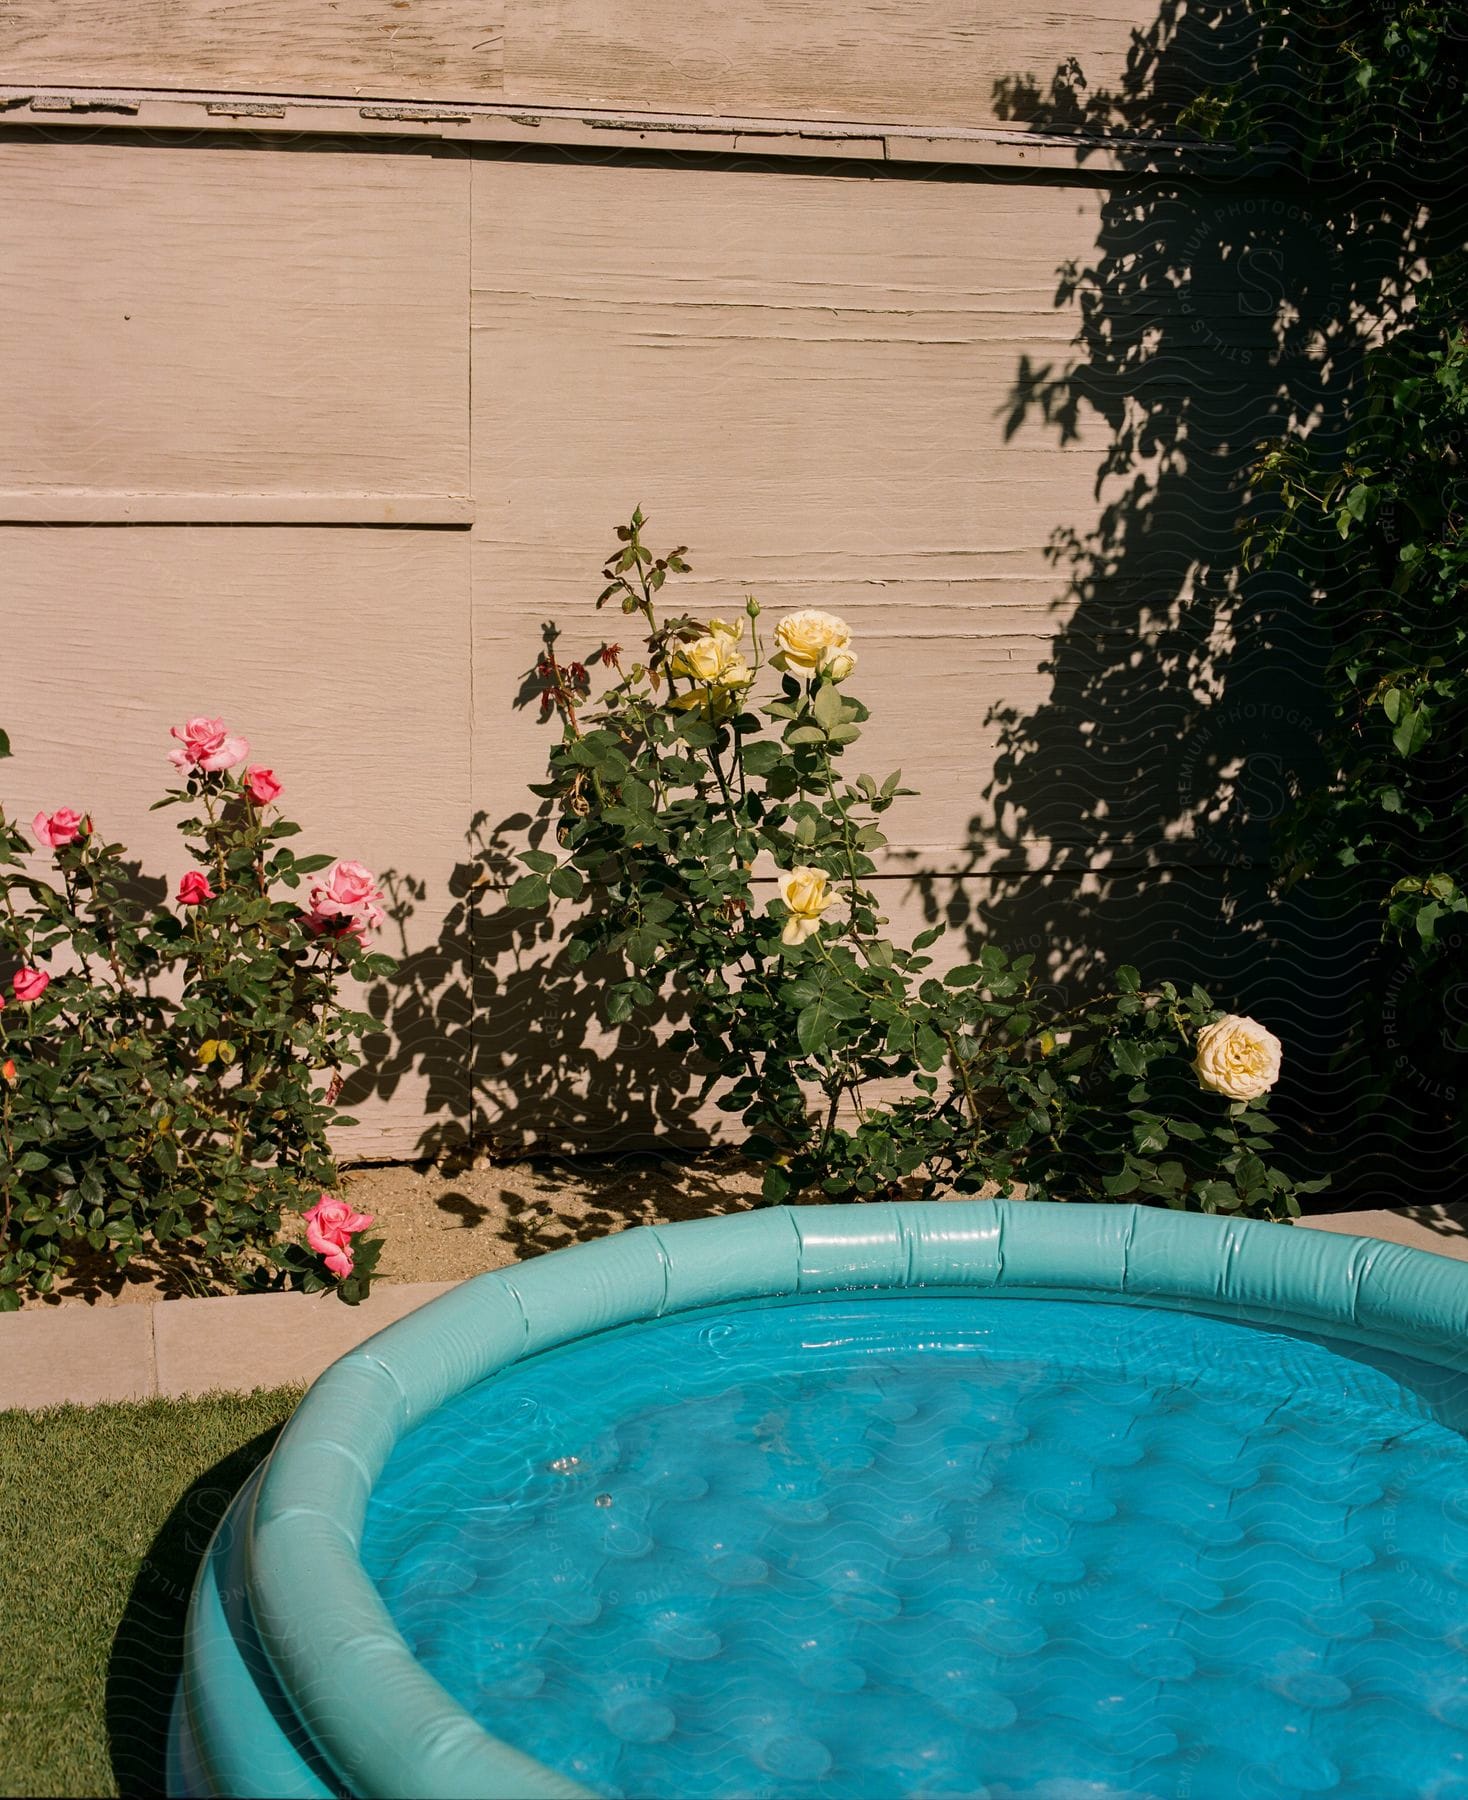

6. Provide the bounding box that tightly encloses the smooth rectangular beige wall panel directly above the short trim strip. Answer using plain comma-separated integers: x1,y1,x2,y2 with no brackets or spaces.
0,140,468,495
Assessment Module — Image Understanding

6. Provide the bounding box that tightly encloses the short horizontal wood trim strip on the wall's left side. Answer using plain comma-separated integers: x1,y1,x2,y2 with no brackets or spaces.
0,488,475,526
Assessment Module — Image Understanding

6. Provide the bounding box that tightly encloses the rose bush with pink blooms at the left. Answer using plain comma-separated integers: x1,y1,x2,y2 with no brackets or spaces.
0,752,394,1310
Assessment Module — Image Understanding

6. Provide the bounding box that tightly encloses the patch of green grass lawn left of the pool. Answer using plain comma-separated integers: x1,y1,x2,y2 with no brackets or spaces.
0,1388,300,1795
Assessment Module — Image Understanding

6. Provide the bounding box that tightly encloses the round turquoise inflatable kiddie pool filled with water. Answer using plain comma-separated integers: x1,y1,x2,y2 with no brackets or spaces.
169,1202,1468,1800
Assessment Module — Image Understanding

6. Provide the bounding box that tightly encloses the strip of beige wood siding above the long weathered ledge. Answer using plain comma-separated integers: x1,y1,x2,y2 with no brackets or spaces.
0,0,1157,128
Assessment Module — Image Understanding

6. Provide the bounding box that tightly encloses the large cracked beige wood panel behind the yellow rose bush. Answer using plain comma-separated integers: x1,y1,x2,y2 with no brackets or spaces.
473,147,1216,1150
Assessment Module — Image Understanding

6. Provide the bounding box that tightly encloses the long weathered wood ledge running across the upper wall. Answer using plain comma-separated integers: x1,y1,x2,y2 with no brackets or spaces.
0,85,1258,176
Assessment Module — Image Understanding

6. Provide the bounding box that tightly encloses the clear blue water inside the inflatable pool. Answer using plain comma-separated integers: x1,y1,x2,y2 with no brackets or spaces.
363,1296,1468,1800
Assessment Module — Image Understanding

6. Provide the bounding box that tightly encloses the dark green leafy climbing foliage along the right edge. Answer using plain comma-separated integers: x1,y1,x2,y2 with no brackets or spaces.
1195,0,1468,1136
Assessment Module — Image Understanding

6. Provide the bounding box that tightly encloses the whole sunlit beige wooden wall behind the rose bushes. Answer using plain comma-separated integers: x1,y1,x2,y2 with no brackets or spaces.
0,0,1288,1157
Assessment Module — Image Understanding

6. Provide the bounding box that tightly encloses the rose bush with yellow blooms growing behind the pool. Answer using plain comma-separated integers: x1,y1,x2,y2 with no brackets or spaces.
509,511,1324,1219
